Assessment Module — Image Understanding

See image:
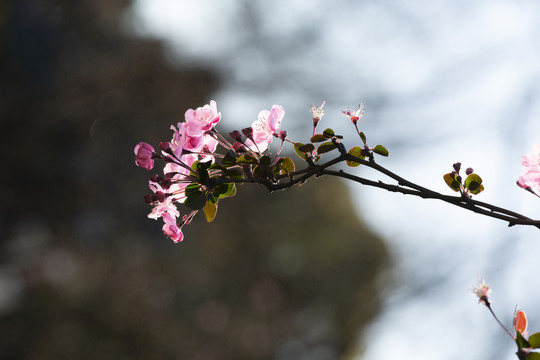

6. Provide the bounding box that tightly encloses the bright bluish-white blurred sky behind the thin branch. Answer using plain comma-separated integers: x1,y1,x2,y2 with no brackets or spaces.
129,0,540,359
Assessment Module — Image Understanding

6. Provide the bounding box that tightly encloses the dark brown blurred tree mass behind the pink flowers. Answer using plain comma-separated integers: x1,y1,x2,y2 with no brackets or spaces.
0,0,388,359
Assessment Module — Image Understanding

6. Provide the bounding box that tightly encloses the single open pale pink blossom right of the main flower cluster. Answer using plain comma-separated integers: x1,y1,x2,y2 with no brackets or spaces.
246,105,285,152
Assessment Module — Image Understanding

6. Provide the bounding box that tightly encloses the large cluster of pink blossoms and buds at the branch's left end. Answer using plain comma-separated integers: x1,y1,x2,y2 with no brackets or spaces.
134,100,286,242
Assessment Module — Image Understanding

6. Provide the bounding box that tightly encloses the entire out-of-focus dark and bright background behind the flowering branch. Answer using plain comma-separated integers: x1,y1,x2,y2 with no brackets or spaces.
0,0,540,359
